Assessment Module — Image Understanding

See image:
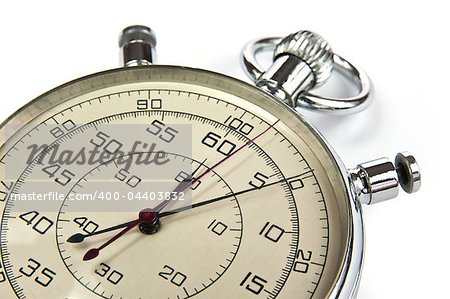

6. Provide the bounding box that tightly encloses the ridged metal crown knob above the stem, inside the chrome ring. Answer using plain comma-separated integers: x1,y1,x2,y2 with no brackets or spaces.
274,30,334,86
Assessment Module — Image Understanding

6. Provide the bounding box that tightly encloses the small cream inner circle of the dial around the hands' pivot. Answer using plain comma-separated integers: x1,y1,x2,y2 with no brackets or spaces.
57,153,242,299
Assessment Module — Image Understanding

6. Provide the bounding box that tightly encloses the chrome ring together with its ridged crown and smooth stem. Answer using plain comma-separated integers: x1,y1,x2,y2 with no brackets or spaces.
242,31,371,114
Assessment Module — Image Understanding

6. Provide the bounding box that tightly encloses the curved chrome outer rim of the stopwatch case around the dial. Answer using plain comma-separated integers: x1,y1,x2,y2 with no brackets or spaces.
0,65,364,299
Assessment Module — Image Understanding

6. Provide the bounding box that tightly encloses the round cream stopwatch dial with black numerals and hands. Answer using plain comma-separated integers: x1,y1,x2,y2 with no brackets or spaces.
0,67,351,299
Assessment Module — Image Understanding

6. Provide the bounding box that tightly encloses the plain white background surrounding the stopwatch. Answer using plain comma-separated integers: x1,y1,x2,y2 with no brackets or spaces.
0,0,450,298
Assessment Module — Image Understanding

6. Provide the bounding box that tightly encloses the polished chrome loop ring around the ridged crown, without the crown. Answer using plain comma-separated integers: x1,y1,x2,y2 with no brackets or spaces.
242,37,371,114
